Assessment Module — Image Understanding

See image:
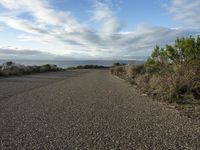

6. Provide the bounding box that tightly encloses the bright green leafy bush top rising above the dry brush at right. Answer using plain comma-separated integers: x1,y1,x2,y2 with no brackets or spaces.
145,36,200,70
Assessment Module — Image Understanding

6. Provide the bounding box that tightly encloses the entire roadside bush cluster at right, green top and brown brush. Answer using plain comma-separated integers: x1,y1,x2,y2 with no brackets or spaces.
111,37,200,103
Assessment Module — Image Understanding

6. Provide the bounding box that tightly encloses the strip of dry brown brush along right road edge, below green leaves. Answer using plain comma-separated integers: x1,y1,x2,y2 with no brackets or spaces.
111,61,200,118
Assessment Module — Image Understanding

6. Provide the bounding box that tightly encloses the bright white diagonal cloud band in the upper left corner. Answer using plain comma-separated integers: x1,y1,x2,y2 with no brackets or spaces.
0,0,81,31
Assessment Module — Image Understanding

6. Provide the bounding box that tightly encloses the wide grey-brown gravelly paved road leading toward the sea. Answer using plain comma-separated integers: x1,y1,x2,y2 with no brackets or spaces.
0,70,200,150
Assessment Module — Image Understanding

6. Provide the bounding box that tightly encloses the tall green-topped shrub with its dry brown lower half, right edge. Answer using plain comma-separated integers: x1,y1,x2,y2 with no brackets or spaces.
145,37,200,102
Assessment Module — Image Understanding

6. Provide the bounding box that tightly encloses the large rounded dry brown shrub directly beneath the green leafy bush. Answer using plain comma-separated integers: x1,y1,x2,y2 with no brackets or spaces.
145,64,200,103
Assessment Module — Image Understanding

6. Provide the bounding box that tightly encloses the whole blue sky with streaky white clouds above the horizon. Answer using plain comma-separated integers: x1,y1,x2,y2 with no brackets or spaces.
0,0,200,60
